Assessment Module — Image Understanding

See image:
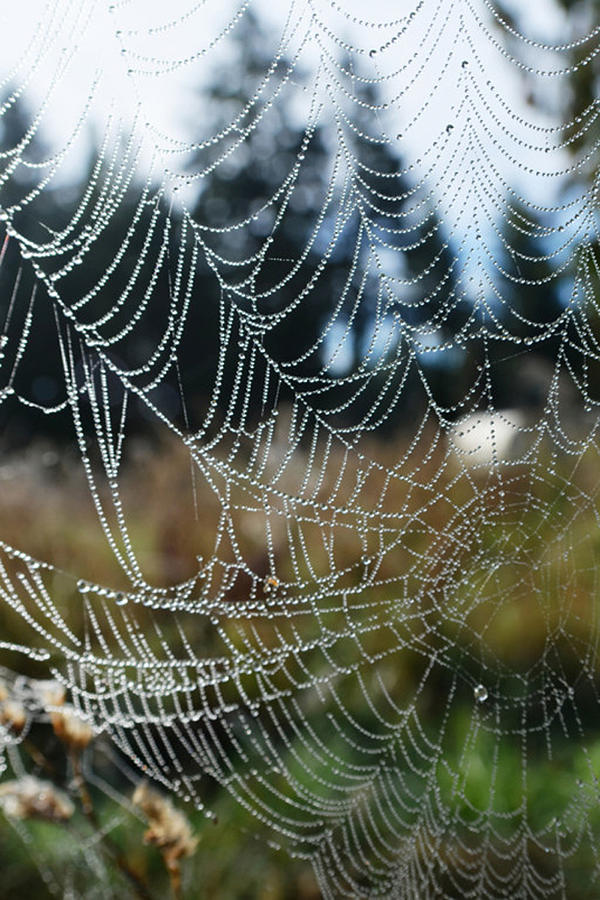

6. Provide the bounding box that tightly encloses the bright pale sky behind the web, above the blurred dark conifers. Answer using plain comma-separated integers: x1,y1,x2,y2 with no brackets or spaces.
0,0,580,374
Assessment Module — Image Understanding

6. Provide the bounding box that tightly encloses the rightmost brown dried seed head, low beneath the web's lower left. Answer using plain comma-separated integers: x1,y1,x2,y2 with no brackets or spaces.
133,781,198,864
